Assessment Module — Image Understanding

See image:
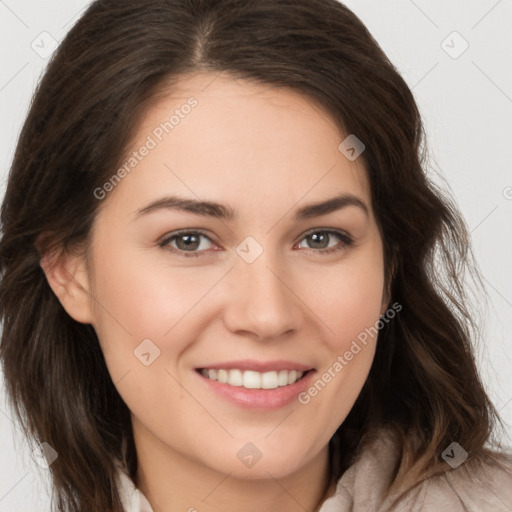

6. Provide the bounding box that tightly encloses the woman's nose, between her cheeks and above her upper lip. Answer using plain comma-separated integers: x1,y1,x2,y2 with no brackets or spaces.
224,251,303,340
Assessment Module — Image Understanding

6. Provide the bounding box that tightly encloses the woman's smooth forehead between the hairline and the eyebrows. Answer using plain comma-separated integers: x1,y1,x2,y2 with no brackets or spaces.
101,69,370,216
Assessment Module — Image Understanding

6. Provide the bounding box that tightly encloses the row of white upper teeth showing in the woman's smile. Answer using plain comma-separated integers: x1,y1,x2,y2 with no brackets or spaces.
201,369,304,389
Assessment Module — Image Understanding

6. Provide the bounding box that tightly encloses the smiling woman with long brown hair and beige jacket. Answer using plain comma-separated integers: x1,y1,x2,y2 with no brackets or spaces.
0,0,512,512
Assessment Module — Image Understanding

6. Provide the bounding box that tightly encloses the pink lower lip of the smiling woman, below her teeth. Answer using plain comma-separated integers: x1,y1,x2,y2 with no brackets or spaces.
196,370,316,410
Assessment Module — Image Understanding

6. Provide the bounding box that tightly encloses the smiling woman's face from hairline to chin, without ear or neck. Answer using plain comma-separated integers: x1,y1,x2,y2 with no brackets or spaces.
70,74,386,478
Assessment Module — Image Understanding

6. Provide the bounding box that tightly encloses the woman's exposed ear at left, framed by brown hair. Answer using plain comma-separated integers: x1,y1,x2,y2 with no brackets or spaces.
40,241,93,324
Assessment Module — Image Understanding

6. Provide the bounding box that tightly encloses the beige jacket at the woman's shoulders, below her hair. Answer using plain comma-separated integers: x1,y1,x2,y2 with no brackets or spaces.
115,431,512,512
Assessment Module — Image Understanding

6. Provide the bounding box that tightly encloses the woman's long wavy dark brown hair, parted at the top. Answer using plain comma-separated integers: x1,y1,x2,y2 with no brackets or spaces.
0,0,508,512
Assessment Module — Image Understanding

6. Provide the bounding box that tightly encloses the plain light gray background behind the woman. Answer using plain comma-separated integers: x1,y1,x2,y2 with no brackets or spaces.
0,0,512,512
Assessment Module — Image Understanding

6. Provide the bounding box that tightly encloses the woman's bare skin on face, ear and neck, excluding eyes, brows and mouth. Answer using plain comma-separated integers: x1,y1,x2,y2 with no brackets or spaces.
41,73,388,512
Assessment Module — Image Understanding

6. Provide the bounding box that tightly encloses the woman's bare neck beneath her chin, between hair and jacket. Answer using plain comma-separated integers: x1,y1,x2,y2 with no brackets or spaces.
134,422,336,512
